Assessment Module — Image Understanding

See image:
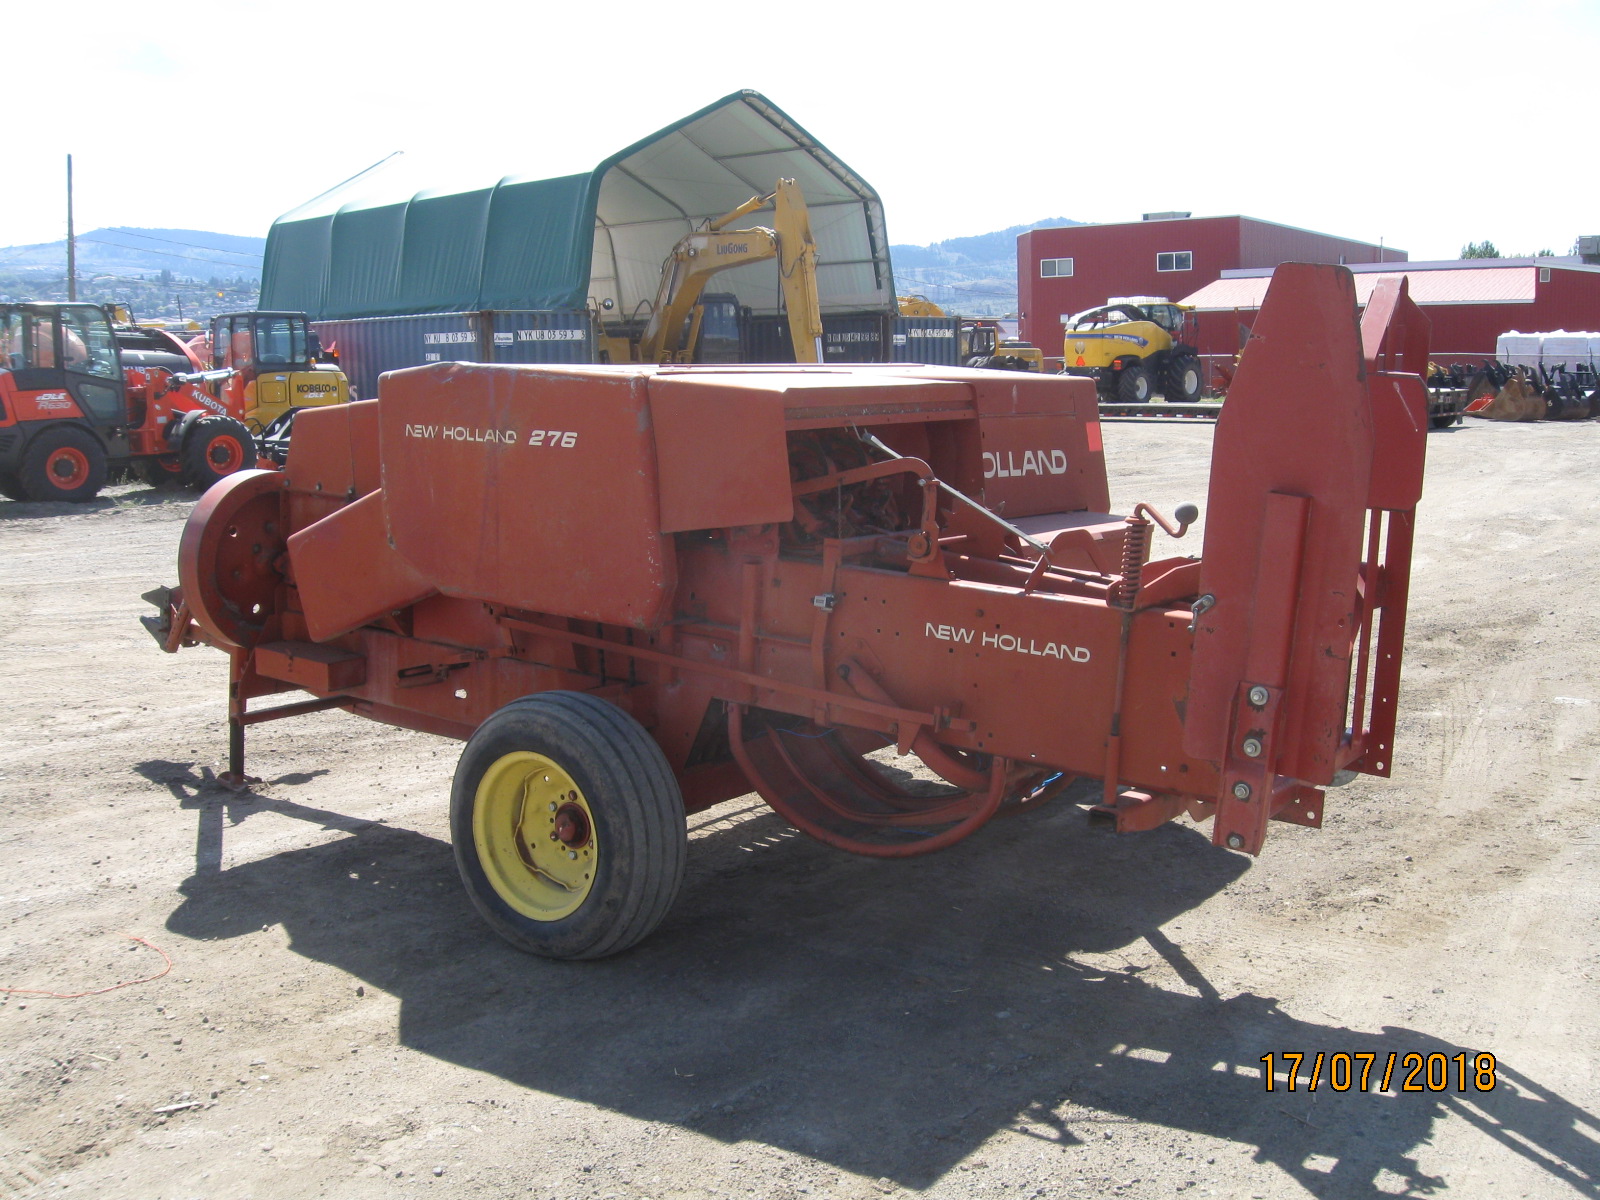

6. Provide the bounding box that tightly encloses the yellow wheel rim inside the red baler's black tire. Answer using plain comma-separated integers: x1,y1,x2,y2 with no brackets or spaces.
472,750,598,922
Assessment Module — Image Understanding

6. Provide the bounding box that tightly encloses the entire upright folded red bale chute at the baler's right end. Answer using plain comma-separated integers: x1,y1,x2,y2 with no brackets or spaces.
1184,262,1429,853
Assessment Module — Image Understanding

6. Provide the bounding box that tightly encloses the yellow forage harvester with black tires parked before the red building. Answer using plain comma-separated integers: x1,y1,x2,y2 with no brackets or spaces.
1062,296,1203,405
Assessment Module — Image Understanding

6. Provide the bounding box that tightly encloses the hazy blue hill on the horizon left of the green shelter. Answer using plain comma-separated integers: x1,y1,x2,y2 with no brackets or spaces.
0,227,267,282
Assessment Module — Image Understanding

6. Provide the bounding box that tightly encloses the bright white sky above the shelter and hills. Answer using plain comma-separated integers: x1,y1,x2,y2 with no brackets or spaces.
12,0,1600,261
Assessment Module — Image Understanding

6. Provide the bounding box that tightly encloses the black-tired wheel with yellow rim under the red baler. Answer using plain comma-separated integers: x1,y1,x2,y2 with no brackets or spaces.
450,691,688,958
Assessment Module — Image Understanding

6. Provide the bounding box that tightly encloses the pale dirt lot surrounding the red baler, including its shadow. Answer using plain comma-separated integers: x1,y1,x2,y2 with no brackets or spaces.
0,422,1600,1200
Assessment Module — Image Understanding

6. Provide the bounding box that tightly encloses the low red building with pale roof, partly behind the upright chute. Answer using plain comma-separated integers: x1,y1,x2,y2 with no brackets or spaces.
1173,258,1600,363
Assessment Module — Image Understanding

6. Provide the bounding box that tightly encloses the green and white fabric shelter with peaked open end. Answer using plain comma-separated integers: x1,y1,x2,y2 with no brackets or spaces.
261,91,894,320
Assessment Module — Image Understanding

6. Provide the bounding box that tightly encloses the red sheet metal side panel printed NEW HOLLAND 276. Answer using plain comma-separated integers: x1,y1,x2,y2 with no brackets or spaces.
379,363,677,629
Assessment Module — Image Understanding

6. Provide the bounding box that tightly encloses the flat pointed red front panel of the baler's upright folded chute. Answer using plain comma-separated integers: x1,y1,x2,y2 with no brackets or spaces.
1184,262,1373,782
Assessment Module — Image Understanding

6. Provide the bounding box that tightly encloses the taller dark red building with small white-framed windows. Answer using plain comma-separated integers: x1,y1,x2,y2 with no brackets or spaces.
1016,213,1406,357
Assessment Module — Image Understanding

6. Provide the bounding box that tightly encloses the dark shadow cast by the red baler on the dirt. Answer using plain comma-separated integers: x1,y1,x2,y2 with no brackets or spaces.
159,784,1600,1197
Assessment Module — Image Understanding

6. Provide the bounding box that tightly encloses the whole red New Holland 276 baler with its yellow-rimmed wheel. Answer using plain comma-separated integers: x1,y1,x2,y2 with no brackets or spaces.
147,264,1427,958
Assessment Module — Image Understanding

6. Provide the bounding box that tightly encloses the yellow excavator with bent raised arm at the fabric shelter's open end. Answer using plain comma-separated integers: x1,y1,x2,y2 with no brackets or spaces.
598,179,822,363
